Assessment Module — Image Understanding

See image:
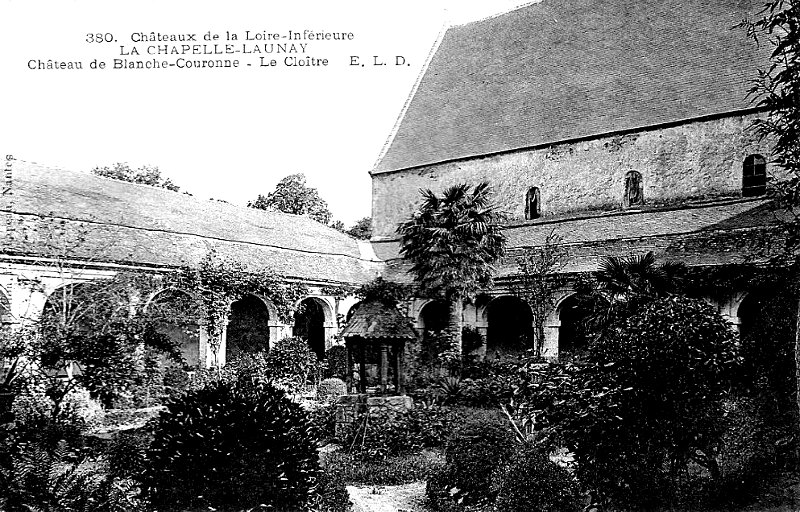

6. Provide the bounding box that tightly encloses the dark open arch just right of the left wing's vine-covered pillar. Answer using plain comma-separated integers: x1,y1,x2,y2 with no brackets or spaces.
225,294,277,360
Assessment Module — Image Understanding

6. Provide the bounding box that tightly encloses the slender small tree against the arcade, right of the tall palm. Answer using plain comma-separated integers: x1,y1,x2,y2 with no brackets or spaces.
514,230,569,357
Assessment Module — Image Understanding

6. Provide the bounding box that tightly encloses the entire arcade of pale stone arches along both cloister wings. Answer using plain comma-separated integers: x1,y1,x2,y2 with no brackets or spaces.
0,258,784,365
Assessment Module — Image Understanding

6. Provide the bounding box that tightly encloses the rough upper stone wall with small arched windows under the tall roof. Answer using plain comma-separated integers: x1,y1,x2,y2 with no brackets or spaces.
372,114,773,239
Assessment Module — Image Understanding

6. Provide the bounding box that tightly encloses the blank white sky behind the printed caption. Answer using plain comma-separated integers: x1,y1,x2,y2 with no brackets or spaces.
0,0,530,225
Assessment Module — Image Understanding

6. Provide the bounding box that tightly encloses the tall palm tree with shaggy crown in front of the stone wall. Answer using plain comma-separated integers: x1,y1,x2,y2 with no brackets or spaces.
397,182,505,350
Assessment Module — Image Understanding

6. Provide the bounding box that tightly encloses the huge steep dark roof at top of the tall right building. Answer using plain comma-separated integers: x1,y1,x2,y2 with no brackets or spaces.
373,0,766,173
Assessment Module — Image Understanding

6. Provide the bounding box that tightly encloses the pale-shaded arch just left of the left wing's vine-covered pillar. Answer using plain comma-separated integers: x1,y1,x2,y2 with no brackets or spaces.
143,287,205,367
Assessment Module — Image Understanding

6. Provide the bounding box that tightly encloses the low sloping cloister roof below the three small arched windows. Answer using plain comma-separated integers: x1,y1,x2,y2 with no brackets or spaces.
377,200,783,282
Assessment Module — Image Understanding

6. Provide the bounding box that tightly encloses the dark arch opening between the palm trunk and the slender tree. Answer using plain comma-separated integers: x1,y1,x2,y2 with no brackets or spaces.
485,295,534,356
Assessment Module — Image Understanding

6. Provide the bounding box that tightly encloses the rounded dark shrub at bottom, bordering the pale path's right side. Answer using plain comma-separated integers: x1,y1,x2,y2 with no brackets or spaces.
426,421,514,510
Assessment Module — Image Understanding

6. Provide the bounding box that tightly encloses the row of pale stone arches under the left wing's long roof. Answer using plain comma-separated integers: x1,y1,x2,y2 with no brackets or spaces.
0,265,356,366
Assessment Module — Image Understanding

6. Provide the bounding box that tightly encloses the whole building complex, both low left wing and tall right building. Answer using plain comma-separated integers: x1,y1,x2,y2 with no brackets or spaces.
0,0,779,363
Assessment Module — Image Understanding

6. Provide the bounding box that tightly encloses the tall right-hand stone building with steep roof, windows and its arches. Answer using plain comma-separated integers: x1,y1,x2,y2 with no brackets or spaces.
371,0,779,357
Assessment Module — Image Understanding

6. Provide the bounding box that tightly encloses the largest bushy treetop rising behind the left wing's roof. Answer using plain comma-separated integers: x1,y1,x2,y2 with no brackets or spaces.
252,173,336,227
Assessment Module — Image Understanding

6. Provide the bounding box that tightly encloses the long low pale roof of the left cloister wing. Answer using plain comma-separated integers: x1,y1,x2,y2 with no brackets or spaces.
0,161,380,283
